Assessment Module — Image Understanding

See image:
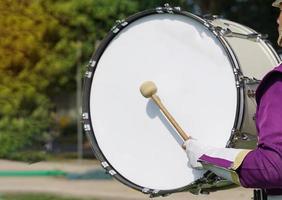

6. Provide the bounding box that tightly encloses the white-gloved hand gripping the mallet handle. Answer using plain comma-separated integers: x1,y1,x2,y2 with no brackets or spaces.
183,138,207,169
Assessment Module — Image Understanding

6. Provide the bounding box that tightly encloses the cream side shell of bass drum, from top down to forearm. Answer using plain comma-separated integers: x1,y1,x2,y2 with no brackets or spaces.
211,18,280,149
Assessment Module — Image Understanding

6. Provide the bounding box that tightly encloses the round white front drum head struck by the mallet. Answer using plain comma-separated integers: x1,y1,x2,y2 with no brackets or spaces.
89,14,237,190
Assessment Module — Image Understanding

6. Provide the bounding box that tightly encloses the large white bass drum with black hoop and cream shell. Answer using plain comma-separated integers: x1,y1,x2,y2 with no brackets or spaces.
82,6,278,196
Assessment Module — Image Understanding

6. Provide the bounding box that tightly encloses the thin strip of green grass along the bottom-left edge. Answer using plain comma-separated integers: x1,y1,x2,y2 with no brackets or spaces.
0,193,98,200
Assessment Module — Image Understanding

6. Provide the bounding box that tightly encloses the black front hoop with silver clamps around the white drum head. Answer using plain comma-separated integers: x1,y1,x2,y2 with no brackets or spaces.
82,6,244,197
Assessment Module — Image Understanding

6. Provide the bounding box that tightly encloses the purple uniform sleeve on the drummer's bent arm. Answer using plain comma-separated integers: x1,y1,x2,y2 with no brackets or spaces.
238,74,282,189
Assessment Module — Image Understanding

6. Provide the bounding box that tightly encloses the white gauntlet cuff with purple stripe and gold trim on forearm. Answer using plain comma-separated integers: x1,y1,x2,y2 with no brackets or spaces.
198,148,250,185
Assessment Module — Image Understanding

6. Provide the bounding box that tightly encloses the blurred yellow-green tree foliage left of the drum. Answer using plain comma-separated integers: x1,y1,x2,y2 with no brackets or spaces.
0,0,140,157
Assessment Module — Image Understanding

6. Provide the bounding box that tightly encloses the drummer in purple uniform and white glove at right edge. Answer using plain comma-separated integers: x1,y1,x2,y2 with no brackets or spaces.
184,0,282,200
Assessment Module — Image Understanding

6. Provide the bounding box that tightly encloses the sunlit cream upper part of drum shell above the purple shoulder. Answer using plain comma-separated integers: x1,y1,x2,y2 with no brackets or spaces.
211,19,280,80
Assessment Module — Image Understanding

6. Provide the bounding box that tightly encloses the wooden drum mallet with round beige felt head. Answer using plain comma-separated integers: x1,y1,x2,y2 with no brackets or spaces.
140,81,191,144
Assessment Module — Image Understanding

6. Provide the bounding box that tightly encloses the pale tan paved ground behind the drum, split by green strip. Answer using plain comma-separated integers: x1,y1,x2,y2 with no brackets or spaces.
0,160,252,200
